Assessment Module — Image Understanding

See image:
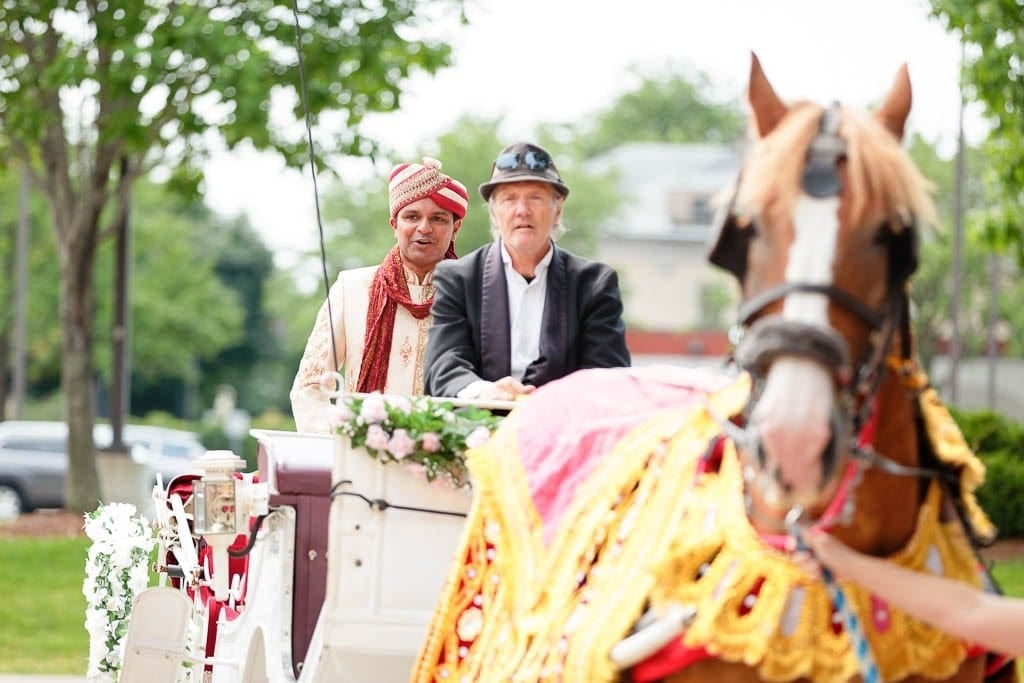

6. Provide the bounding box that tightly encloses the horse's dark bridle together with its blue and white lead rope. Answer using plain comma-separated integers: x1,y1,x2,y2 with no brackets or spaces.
709,103,995,683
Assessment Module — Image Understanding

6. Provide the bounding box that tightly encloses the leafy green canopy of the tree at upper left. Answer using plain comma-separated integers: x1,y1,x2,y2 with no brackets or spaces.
0,0,464,189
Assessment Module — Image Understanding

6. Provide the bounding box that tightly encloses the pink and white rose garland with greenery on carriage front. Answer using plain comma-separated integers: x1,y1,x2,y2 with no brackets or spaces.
329,392,503,488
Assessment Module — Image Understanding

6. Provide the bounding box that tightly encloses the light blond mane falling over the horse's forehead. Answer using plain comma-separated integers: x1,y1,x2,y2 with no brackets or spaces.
733,101,937,230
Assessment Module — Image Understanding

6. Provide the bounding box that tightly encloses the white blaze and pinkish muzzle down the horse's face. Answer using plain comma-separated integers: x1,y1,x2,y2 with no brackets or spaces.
752,196,840,502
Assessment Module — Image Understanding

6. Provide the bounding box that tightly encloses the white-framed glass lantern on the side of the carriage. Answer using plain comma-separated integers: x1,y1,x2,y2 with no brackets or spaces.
193,451,269,600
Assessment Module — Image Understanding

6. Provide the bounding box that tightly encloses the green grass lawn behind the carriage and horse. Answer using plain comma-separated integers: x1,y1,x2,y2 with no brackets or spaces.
0,538,1024,675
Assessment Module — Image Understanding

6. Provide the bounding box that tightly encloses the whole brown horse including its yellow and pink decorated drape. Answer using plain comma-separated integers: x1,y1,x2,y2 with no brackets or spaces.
413,57,1012,683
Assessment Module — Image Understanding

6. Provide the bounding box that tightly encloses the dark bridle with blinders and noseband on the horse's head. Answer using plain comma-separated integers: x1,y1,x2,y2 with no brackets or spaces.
709,103,942,491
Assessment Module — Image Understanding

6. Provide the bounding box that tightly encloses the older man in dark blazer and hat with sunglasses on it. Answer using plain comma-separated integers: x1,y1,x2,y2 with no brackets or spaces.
425,142,630,400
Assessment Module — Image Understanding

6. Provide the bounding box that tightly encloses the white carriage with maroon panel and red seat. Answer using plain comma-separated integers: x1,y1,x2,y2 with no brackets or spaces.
121,395,495,683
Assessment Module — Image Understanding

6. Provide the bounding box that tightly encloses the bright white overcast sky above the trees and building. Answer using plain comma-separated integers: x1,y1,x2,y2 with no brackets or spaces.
201,0,977,272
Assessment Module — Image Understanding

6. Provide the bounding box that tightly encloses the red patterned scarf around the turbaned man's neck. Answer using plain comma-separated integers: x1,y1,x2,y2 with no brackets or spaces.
355,240,456,393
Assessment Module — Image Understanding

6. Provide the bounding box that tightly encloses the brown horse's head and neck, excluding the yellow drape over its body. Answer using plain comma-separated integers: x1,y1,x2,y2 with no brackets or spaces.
667,56,1007,683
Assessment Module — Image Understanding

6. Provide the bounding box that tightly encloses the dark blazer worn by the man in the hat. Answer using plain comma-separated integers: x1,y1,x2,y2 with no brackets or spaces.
423,241,630,396
